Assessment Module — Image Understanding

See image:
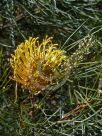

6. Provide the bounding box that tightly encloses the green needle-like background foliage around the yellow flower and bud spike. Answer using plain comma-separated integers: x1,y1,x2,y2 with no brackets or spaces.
0,0,102,136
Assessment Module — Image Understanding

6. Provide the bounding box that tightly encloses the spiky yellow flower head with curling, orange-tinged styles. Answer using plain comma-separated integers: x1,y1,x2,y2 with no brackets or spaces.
10,36,67,94
